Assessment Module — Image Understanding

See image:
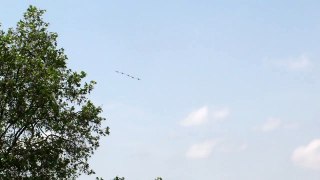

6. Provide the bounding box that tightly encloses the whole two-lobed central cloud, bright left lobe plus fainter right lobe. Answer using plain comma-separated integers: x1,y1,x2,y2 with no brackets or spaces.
180,106,230,126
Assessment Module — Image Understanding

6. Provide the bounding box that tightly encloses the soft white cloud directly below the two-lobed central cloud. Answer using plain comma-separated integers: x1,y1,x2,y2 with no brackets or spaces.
186,140,217,159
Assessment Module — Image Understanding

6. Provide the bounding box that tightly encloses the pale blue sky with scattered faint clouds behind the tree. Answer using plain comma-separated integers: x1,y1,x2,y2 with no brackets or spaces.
0,0,320,180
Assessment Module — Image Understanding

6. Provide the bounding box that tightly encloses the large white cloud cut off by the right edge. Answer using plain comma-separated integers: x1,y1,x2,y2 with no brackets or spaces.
292,139,320,170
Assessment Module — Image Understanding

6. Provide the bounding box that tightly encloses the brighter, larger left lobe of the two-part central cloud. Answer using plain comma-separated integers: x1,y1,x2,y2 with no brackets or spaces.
181,106,209,126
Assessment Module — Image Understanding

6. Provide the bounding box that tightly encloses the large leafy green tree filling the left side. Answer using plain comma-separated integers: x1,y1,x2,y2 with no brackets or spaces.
0,6,109,179
